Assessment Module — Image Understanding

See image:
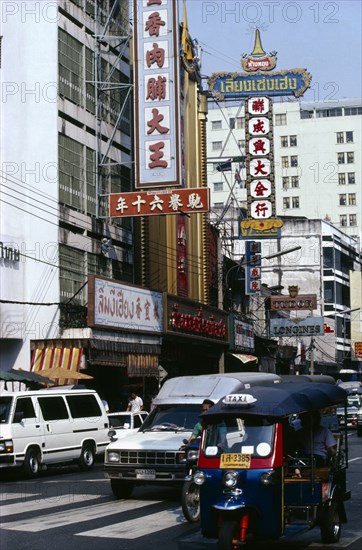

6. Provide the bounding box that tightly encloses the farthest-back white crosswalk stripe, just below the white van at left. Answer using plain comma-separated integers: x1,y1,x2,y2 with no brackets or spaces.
1,494,102,517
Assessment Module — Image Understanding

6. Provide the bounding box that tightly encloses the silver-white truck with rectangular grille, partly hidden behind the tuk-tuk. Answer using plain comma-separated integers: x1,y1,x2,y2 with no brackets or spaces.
104,372,281,498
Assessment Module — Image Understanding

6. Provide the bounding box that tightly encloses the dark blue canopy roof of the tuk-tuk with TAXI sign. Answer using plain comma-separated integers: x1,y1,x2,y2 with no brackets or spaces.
201,382,347,418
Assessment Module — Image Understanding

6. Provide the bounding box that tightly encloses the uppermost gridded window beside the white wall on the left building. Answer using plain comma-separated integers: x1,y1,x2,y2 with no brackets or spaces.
58,29,83,105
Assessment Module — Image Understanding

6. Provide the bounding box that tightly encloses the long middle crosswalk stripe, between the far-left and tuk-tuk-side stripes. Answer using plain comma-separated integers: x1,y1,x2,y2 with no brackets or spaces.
2,497,162,535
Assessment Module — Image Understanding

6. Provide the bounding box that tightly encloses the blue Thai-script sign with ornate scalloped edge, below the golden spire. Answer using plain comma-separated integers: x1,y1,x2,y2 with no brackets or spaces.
208,69,312,100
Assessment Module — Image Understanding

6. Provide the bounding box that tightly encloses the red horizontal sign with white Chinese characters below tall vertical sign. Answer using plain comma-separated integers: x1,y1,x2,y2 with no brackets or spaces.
109,187,210,218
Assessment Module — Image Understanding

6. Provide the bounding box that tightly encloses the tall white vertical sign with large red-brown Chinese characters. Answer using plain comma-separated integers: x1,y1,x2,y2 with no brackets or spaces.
133,0,181,189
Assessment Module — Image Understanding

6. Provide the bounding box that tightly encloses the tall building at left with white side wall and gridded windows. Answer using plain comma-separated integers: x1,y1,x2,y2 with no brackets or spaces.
0,0,133,369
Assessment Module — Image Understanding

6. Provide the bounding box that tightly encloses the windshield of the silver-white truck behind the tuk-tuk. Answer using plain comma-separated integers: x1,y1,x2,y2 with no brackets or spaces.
141,405,201,432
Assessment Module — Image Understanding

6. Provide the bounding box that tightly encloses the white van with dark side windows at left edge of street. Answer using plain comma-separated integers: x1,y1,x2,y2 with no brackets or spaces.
0,387,109,477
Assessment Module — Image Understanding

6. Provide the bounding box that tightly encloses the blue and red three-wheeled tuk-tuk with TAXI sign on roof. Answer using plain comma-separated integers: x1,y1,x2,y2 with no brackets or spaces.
194,382,350,550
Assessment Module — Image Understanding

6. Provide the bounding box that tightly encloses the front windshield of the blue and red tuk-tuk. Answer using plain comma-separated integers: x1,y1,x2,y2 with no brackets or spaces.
203,416,275,458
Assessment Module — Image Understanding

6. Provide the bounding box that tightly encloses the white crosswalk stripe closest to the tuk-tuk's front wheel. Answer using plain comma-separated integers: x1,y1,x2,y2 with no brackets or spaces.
77,506,187,539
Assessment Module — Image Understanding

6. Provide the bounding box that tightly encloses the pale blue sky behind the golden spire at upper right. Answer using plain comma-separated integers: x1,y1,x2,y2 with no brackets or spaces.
179,0,362,102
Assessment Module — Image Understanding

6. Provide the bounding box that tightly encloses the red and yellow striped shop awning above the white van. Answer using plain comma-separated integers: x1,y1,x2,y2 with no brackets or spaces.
31,347,83,385
